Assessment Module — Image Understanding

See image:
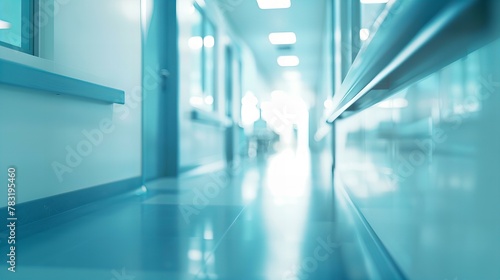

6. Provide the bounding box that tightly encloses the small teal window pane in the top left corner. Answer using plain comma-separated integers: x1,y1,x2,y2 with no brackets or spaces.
0,0,33,54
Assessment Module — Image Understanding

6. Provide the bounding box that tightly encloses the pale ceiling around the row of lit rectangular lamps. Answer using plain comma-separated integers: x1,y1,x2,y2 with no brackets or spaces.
219,0,327,96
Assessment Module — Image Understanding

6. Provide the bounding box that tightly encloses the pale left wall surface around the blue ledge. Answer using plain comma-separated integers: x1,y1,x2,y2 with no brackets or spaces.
0,0,141,206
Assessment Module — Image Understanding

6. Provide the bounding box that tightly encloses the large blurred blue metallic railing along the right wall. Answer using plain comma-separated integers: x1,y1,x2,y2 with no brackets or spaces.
316,0,500,139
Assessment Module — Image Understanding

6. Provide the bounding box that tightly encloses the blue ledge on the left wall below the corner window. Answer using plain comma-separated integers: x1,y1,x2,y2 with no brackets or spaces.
0,59,125,104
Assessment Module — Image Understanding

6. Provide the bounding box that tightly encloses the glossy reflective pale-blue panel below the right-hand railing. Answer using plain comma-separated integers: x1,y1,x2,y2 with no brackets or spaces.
335,41,500,280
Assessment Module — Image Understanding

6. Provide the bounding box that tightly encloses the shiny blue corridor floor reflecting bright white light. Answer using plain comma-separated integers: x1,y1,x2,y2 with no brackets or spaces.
0,150,371,280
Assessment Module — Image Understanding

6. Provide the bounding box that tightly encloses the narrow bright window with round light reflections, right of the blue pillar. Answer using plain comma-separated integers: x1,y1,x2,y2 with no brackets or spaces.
188,4,216,111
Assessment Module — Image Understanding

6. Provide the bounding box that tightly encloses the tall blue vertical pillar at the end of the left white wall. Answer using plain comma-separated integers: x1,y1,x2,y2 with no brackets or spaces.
141,0,179,181
